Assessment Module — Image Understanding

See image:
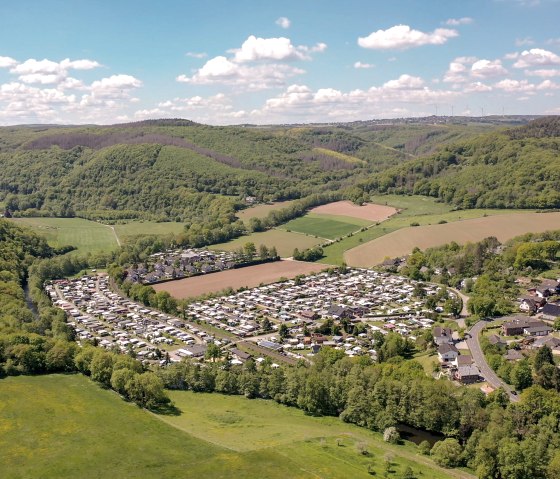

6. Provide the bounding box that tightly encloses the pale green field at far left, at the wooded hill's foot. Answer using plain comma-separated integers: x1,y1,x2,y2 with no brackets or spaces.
10,218,118,254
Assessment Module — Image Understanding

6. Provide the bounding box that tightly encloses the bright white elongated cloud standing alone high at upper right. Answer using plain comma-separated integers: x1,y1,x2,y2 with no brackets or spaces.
358,25,459,50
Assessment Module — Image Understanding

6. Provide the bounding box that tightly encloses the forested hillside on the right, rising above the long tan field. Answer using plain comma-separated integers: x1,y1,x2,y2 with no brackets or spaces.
361,117,560,208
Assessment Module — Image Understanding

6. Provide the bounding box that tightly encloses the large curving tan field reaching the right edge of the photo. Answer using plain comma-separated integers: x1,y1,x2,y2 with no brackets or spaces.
344,213,560,267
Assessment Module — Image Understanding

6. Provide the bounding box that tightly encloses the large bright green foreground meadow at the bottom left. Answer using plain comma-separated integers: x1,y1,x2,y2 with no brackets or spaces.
0,375,473,479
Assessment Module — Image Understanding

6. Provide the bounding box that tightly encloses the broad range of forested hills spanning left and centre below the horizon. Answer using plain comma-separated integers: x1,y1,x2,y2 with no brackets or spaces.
0,120,496,224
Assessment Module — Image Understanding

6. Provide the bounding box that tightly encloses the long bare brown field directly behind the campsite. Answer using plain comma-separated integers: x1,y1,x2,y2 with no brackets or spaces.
153,260,328,299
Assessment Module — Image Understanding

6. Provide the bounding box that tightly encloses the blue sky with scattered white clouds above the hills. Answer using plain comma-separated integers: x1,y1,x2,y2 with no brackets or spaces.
0,0,560,125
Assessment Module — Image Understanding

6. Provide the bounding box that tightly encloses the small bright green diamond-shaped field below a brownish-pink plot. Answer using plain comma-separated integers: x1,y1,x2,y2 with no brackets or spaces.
278,213,372,239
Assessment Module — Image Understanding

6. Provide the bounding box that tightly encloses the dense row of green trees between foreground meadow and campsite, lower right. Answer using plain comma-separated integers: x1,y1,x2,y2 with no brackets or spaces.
157,348,560,479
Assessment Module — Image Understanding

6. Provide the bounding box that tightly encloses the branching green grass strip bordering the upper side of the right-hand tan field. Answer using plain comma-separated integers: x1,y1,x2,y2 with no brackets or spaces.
321,195,526,264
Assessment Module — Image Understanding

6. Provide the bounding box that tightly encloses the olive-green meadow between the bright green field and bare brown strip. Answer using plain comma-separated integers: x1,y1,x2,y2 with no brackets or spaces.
209,229,324,258
